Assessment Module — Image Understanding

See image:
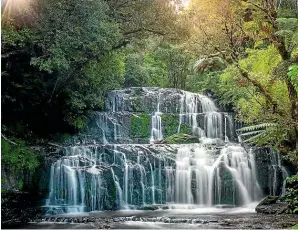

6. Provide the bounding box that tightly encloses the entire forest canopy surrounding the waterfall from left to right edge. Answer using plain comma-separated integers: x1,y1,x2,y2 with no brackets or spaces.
1,0,298,158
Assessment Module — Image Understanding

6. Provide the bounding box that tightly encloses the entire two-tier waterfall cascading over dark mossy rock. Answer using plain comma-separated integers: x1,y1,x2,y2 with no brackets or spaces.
46,88,286,213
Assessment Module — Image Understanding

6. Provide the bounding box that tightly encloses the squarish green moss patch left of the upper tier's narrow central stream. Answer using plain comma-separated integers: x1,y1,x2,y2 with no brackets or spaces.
130,114,150,138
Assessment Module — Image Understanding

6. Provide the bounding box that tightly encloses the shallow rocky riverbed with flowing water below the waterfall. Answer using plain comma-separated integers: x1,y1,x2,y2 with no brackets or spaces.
24,208,298,229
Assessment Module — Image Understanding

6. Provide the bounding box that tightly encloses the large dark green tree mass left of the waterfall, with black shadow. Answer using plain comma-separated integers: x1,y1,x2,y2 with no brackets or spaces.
1,0,124,135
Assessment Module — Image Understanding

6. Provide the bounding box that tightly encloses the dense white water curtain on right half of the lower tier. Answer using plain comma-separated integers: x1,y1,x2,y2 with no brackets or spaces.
175,144,261,206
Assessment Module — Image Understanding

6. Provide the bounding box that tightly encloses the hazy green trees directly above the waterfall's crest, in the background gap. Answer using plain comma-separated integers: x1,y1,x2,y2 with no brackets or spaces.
124,42,193,89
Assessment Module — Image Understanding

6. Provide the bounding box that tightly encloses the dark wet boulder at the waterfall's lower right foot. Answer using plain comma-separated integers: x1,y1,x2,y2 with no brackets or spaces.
256,196,288,214
